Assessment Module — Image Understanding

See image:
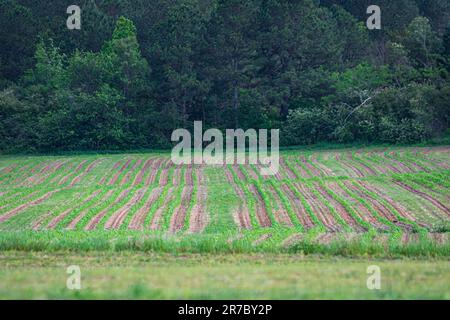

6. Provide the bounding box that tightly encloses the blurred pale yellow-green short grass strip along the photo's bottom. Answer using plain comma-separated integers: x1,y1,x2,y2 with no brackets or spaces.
0,251,450,299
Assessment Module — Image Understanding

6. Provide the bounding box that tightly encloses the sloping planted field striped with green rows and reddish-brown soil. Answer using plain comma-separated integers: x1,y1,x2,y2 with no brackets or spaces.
0,147,450,255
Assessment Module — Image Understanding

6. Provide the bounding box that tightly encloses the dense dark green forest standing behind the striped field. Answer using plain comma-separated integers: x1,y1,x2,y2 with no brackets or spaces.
0,0,450,152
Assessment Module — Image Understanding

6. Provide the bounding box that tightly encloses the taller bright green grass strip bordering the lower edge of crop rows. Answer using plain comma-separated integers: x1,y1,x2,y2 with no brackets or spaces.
0,228,450,258
